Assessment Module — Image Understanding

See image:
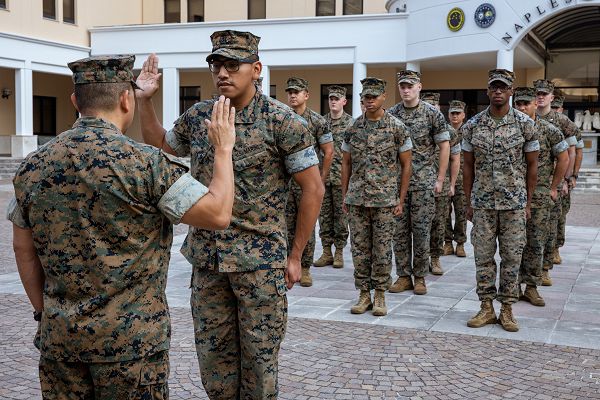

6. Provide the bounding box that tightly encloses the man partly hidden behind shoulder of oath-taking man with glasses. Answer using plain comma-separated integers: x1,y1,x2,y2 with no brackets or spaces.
285,77,333,286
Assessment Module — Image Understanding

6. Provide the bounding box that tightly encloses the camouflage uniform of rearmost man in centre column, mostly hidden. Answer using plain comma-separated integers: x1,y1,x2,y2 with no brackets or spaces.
445,125,467,244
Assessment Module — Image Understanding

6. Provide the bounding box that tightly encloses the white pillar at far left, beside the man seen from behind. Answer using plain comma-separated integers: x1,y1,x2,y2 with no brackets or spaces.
11,62,37,157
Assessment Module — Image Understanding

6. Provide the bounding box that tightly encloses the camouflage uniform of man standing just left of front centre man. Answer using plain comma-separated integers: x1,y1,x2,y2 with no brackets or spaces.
319,113,354,249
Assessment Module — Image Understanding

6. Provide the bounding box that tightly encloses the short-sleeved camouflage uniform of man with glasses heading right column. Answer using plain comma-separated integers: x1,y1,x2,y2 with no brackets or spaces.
461,107,540,304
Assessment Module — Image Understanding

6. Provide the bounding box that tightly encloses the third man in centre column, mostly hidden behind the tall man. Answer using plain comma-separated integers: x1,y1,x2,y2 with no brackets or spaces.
421,92,460,275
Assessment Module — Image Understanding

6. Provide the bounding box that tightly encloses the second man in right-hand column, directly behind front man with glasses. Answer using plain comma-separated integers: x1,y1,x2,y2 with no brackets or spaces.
514,87,569,306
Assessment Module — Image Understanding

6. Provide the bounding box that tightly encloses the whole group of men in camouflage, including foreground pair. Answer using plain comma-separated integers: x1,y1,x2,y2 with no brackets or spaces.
8,30,583,399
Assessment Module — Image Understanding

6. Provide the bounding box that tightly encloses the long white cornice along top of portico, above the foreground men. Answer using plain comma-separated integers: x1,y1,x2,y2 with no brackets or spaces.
88,12,409,33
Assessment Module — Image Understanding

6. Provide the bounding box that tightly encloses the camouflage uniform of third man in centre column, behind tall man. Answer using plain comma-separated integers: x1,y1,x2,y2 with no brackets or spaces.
430,124,460,258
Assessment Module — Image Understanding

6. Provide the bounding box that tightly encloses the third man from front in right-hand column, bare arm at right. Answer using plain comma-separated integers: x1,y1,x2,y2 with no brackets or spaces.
533,79,583,272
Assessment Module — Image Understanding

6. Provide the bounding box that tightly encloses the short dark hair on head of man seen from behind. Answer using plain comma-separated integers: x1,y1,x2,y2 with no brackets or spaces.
74,82,133,114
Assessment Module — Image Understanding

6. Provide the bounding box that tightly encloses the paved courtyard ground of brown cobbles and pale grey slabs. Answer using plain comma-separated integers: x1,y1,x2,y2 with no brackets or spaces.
0,182,600,400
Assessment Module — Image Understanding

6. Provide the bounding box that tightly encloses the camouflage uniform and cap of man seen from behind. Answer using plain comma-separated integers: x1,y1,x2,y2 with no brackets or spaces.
8,56,213,399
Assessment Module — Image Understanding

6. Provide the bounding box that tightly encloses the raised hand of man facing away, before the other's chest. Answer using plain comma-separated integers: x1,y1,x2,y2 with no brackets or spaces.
204,96,235,150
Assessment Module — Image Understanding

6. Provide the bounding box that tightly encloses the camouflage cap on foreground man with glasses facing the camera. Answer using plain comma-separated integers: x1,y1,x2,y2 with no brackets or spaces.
206,30,260,62
